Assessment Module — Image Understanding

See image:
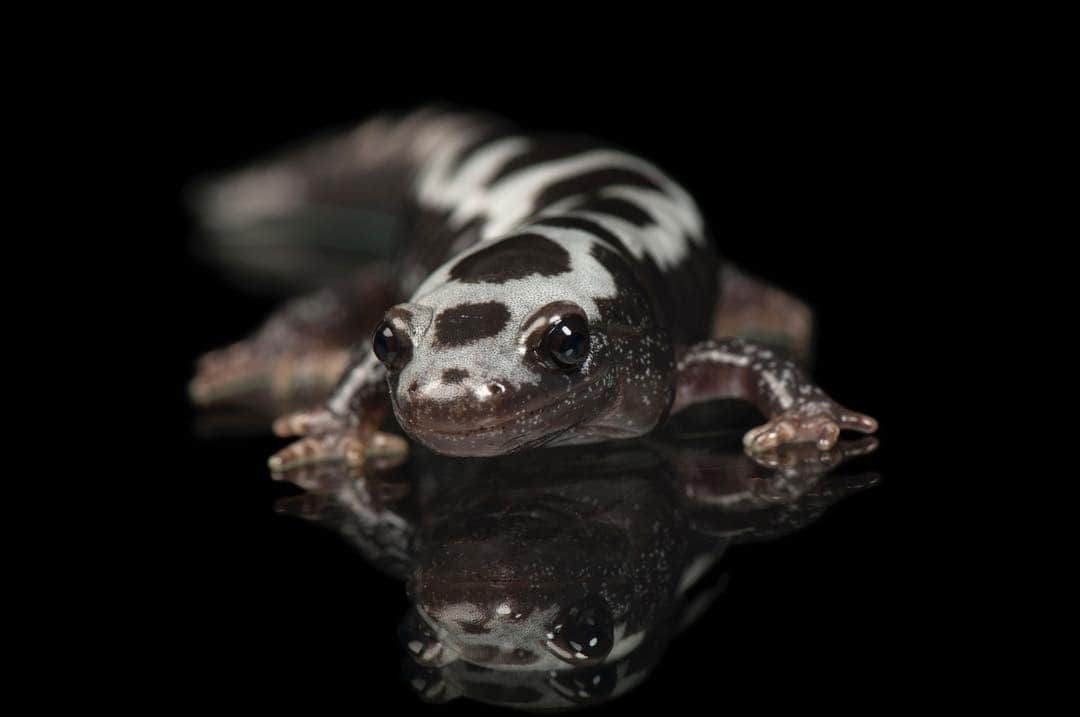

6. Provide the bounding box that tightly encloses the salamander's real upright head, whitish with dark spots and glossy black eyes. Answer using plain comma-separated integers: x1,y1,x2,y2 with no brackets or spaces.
373,228,670,456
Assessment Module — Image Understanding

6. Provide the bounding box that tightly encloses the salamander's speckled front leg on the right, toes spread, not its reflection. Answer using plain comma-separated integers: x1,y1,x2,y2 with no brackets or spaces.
672,339,878,454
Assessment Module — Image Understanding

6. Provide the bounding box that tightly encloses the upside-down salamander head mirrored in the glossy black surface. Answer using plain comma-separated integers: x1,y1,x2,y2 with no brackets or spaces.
409,496,630,669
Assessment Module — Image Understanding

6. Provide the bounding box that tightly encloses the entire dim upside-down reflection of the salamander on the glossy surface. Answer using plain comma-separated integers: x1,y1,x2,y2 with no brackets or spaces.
284,427,873,708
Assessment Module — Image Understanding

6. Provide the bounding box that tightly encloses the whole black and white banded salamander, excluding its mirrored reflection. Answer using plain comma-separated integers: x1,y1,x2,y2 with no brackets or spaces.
192,106,876,470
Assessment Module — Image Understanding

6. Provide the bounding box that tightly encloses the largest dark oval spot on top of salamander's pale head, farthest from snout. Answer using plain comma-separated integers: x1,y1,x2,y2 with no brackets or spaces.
450,234,570,284
